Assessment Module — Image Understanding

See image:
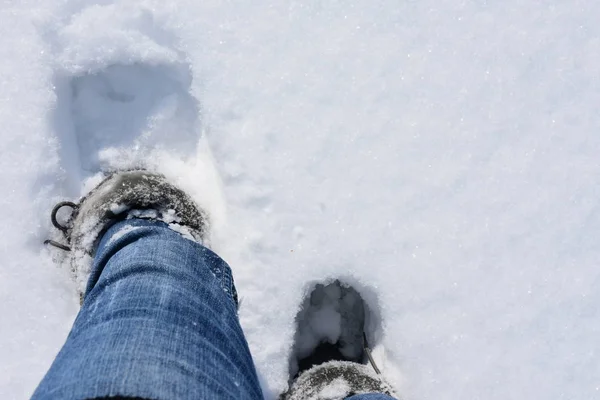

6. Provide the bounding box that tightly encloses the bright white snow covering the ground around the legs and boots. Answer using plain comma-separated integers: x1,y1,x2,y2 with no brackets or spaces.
0,0,600,400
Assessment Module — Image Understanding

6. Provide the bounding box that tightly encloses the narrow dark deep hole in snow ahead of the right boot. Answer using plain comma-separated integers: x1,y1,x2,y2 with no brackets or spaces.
290,279,381,378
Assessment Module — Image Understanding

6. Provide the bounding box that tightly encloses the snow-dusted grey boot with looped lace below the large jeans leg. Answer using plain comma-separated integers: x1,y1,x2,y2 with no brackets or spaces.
46,170,208,294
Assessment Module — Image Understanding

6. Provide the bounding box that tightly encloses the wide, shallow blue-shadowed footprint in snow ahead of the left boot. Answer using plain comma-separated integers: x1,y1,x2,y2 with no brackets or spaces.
53,62,201,177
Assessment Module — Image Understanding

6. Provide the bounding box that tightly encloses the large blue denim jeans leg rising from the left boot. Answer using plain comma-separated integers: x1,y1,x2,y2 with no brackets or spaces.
33,219,262,400
